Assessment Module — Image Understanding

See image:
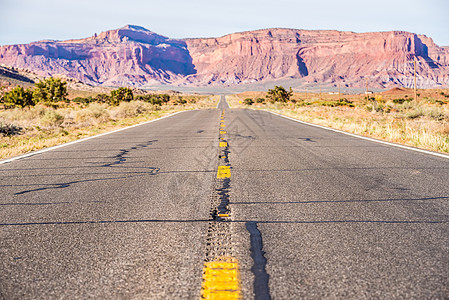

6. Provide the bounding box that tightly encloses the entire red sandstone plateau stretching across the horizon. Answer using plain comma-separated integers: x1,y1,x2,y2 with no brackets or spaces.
0,25,449,88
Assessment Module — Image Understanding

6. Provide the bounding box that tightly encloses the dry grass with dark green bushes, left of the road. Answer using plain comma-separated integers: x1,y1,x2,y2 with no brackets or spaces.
0,78,218,159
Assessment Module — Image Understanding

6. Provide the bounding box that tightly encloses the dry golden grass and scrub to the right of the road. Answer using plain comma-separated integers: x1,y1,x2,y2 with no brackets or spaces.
228,88,449,153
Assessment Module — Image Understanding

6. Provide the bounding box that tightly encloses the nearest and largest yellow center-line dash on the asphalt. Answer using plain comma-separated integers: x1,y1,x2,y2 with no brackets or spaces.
201,257,241,300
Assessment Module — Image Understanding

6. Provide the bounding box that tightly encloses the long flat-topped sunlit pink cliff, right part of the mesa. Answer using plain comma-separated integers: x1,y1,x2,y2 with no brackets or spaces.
184,29,449,87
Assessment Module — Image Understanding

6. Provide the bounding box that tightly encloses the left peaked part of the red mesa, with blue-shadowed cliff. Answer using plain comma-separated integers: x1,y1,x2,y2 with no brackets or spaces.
0,25,195,86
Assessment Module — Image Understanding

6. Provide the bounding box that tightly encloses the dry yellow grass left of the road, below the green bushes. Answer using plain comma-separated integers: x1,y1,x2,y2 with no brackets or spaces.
0,96,219,159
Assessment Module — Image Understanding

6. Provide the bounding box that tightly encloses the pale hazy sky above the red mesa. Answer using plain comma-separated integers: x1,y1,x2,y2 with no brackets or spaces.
0,0,449,46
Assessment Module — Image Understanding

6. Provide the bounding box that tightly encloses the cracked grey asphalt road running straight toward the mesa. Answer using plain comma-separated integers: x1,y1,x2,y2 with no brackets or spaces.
0,97,449,299
